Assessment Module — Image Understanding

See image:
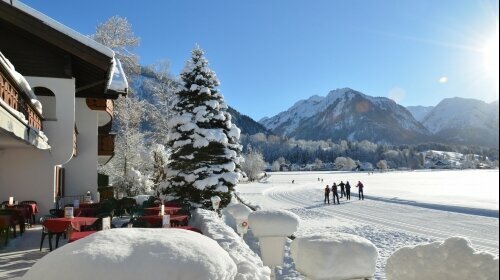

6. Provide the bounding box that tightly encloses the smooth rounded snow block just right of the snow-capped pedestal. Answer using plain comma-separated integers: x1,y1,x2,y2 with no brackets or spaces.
290,233,379,280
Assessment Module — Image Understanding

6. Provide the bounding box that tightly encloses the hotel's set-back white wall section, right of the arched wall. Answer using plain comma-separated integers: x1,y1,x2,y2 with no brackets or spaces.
63,98,97,198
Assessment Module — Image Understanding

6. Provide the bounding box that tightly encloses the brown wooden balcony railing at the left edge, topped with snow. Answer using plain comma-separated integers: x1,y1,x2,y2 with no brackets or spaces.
0,66,42,130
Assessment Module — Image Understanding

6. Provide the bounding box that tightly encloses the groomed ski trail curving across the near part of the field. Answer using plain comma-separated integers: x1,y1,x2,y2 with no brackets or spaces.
238,170,499,280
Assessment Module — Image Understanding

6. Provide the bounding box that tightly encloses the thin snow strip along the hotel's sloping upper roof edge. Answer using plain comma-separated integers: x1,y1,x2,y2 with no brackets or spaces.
2,0,115,58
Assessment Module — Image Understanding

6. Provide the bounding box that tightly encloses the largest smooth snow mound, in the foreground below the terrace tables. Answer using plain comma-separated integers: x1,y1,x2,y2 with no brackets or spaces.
23,228,236,280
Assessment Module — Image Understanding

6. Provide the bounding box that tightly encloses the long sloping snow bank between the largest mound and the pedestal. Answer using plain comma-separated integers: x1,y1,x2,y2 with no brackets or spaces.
191,209,271,280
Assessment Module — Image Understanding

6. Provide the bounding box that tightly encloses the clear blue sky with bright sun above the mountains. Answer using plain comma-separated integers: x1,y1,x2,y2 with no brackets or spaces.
22,0,499,120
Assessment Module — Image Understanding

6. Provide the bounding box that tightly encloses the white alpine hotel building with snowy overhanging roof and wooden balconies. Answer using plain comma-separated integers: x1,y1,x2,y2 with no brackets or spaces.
0,0,128,213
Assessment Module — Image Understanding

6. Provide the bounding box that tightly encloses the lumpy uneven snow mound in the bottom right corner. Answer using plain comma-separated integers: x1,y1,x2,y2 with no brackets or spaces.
386,237,499,280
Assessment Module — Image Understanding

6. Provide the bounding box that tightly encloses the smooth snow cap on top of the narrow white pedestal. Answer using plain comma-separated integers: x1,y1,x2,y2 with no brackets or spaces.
248,210,300,237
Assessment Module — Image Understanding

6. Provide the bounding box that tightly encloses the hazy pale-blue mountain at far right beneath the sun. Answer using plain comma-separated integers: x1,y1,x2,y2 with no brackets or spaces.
422,97,499,147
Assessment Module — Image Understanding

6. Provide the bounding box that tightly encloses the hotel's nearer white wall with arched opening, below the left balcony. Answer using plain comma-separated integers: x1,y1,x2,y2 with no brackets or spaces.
0,77,75,214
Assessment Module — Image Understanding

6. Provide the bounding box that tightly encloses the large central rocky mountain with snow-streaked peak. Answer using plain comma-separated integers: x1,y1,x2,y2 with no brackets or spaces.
261,88,429,144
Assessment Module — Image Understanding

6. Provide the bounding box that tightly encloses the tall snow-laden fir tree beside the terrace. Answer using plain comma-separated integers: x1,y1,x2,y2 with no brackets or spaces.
163,47,241,209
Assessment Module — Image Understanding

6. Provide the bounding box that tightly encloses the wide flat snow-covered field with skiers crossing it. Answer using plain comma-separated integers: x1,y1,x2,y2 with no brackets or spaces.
237,170,499,279
